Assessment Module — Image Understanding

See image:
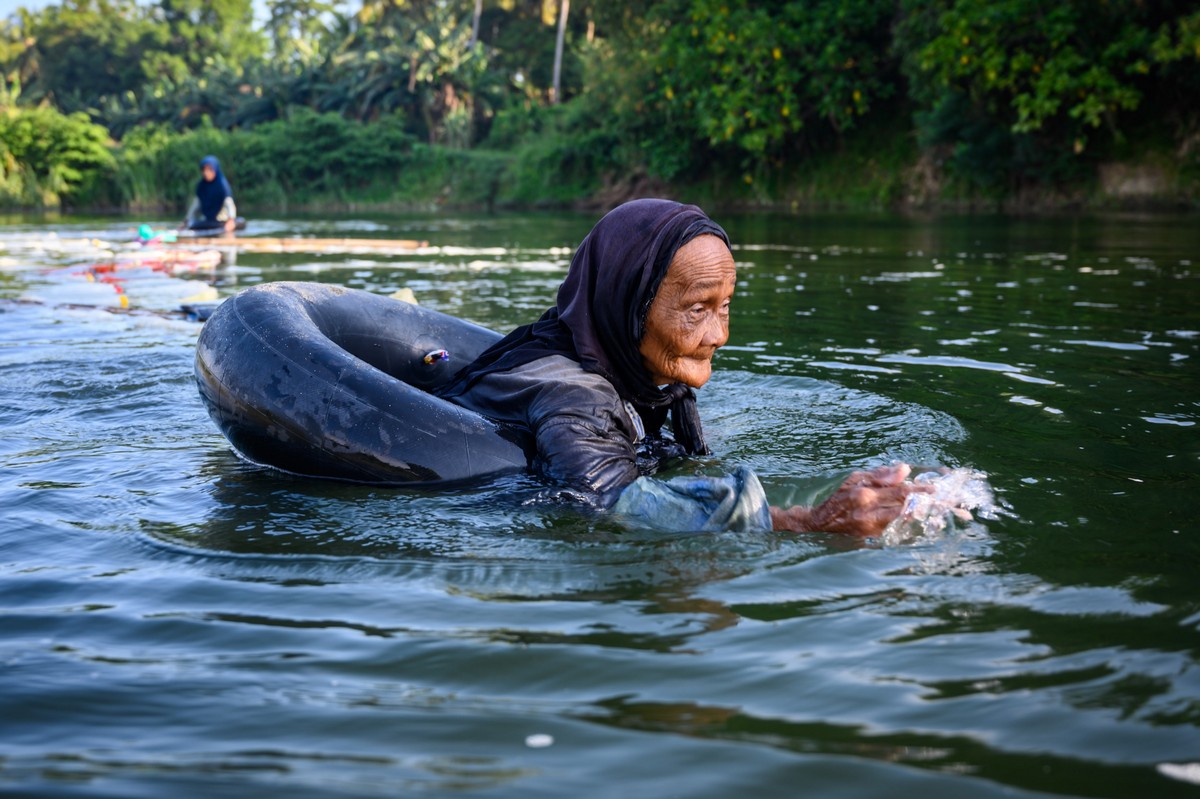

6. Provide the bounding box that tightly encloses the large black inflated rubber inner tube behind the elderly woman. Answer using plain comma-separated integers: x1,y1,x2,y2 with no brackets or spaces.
196,277,529,485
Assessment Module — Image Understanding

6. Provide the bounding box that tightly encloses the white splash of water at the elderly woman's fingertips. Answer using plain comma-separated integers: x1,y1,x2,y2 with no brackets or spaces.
881,469,1000,545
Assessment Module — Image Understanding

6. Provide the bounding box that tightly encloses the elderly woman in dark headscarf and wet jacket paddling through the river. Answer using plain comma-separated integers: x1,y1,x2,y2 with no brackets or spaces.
440,199,925,535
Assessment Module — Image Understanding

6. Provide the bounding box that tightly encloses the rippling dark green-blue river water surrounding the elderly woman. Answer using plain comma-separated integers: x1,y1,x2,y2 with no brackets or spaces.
0,208,1200,798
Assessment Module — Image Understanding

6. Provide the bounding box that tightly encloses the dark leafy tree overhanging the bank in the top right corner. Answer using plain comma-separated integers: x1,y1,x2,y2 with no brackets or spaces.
895,0,1196,192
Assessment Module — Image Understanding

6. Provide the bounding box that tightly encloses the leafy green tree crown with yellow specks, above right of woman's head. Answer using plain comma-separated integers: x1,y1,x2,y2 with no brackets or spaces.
604,0,894,176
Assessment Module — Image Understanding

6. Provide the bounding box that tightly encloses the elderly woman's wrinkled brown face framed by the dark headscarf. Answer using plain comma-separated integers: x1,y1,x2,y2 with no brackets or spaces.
638,235,738,389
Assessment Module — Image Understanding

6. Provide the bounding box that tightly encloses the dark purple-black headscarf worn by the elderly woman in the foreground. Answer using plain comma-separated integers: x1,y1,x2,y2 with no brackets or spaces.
440,199,730,455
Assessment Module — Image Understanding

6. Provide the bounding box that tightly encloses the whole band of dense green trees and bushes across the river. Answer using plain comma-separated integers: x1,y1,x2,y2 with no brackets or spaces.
0,0,1200,209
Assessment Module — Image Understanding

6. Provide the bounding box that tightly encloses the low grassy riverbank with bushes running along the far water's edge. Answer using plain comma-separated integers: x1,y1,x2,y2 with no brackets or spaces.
0,105,1200,215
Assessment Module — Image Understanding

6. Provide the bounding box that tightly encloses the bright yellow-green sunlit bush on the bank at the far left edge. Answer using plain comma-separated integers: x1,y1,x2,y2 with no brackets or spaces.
0,108,113,208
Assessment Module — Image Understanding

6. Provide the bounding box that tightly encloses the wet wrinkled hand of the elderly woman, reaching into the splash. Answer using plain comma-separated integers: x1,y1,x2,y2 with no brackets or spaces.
770,463,932,536
